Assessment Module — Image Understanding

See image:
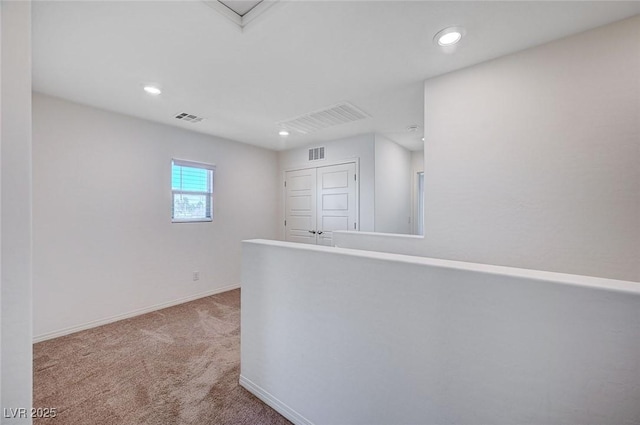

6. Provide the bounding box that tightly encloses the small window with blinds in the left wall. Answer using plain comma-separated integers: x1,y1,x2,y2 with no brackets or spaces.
171,159,216,223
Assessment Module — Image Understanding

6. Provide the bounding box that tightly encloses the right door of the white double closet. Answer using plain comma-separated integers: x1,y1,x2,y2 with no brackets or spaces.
316,162,358,246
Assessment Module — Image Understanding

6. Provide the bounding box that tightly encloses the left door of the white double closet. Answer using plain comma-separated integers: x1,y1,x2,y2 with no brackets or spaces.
285,168,317,244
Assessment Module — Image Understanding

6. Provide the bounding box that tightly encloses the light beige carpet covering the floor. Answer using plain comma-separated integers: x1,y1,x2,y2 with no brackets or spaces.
34,290,290,425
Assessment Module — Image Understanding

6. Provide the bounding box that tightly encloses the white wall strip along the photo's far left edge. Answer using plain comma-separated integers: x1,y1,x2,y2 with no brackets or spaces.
0,1,32,424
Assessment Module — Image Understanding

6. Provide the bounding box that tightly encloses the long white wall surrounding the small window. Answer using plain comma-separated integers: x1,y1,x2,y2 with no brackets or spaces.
33,93,278,338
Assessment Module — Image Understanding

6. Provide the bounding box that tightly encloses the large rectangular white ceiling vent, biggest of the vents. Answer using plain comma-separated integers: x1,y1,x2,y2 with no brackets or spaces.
277,102,370,134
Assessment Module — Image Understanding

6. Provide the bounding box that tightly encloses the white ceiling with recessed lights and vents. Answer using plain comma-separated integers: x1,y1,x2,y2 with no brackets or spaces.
32,0,640,150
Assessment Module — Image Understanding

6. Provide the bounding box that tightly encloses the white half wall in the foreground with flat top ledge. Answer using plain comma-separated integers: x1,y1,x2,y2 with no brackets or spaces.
240,241,640,425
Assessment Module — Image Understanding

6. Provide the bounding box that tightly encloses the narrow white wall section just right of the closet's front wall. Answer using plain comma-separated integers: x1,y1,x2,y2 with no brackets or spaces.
375,134,412,234
